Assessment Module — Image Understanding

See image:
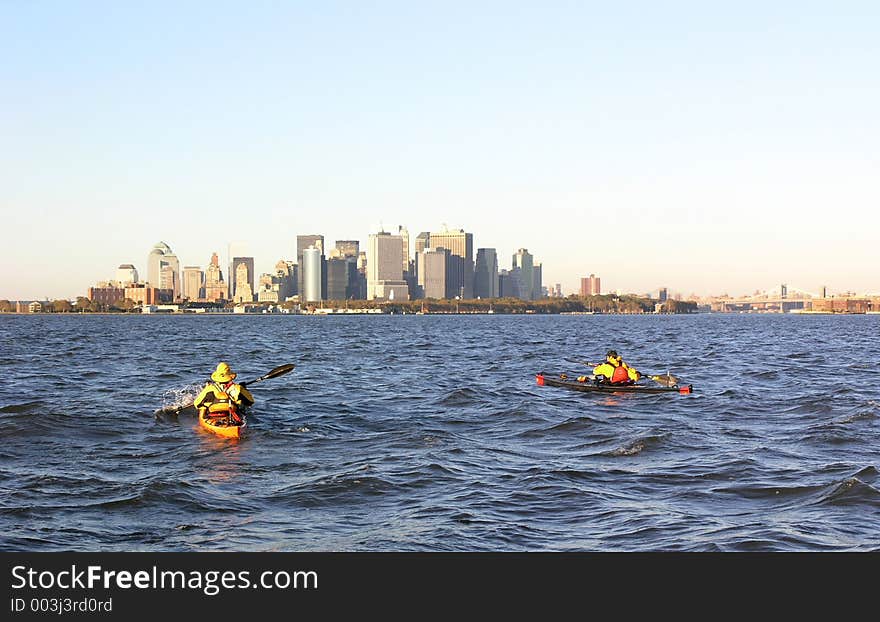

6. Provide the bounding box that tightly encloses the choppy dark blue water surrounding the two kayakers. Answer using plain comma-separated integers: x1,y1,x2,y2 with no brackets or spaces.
0,315,880,551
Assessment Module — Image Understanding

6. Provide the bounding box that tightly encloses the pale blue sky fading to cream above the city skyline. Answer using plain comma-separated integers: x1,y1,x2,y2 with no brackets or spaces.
0,0,880,299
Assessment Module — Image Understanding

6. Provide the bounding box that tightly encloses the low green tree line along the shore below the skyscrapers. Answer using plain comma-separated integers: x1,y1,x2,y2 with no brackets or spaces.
0,294,697,314
